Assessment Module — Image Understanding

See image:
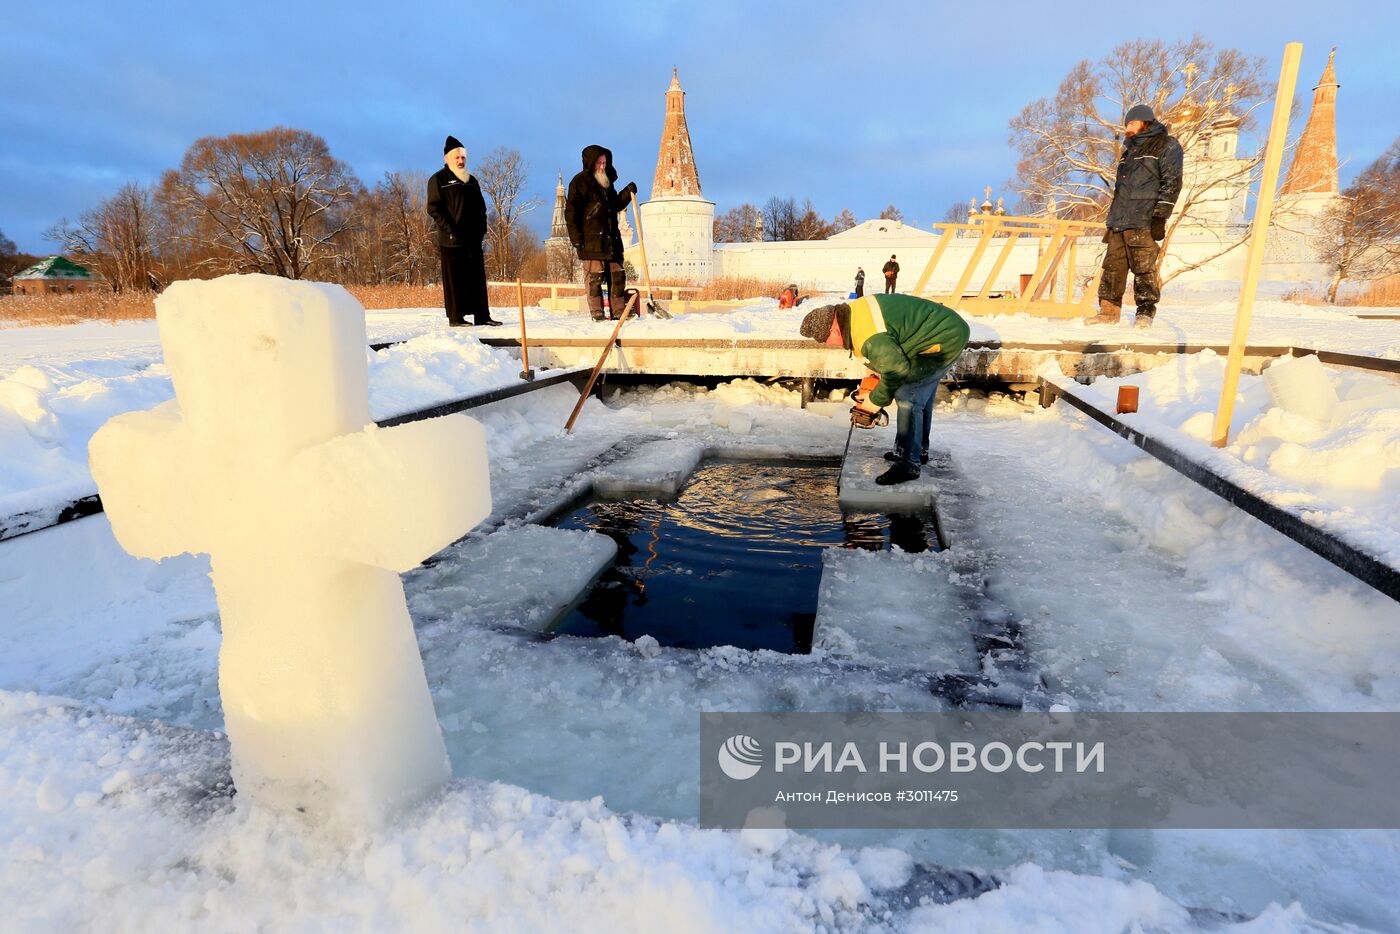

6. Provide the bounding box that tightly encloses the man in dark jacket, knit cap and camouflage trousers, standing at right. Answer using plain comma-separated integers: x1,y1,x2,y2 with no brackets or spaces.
1088,104,1183,328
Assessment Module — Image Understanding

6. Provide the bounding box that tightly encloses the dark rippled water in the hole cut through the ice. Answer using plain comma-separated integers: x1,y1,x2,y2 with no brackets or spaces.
554,462,938,654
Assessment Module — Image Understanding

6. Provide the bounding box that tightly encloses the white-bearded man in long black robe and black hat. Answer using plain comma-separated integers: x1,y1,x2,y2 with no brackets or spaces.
427,136,501,328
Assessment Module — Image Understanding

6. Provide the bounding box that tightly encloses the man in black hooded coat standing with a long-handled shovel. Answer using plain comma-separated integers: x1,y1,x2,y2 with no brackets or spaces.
564,146,637,321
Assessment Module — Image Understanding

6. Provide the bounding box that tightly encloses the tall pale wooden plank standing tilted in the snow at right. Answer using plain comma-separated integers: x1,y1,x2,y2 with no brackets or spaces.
1211,42,1303,448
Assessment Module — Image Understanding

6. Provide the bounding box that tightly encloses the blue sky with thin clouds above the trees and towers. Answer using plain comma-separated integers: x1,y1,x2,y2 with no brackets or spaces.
0,0,1400,253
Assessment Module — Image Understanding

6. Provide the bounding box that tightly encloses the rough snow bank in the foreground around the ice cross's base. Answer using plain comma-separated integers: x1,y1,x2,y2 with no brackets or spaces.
0,692,1308,931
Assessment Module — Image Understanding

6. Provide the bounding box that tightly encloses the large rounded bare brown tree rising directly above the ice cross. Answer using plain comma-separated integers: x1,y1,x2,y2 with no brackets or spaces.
160,126,360,279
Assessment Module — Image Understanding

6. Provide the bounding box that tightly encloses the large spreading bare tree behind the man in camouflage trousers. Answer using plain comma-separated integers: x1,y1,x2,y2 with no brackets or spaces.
1009,35,1289,281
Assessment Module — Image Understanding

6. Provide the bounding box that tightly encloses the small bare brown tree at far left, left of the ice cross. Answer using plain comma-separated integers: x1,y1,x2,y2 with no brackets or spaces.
48,182,155,291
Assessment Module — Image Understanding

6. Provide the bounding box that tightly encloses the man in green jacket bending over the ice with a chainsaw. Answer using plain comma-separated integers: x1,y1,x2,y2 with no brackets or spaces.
802,295,970,486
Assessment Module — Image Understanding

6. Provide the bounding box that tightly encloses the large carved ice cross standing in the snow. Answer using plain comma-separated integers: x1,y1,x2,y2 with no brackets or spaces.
88,276,490,825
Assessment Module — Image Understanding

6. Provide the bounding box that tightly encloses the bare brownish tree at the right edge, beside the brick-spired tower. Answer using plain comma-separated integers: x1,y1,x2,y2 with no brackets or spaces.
1313,139,1400,302
